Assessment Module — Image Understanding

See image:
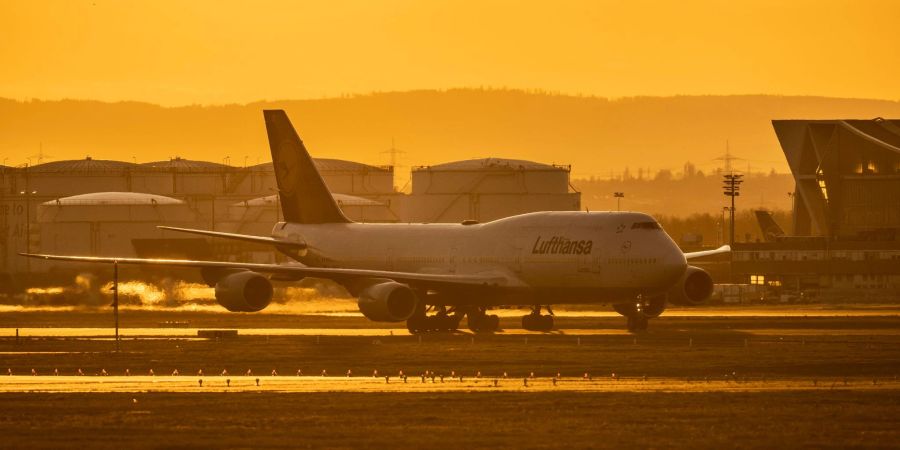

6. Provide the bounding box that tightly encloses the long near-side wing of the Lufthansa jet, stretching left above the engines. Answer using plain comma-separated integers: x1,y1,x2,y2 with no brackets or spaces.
19,253,517,289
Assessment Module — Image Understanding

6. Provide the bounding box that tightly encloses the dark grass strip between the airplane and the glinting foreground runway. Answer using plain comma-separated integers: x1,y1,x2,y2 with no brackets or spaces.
0,313,900,379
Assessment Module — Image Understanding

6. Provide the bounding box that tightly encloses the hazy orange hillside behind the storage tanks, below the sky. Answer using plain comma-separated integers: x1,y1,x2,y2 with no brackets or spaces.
0,90,900,192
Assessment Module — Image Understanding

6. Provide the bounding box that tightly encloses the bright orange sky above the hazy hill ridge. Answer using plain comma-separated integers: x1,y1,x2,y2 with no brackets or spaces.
0,0,900,105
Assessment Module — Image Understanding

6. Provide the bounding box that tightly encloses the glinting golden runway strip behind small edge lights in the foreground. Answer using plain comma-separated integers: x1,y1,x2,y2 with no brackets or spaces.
0,375,900,393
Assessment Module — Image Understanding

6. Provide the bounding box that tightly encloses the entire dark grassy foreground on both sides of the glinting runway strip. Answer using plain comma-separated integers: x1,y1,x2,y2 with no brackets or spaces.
0,313,900,448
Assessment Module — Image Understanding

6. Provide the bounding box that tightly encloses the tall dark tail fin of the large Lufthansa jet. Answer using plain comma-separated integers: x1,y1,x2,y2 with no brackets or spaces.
263,109,350,224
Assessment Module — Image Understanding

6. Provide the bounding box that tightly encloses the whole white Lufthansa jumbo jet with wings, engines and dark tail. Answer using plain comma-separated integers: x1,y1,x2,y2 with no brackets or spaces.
23,110,730,333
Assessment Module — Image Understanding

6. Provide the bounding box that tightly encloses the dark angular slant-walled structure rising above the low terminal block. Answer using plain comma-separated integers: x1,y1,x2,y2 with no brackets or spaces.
772,119,900,241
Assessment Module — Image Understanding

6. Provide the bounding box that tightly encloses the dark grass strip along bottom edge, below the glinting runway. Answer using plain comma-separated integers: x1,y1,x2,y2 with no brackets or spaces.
0,391,900,448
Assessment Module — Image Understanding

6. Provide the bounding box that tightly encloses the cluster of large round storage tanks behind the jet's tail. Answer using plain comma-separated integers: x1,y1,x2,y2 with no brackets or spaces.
0,157,580,286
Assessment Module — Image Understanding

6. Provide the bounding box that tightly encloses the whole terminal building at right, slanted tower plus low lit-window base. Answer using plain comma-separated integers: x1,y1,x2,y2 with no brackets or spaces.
732,118,900,291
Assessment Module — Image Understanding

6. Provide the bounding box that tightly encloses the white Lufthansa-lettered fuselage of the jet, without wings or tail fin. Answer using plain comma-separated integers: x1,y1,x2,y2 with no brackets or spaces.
272,212,687,304
